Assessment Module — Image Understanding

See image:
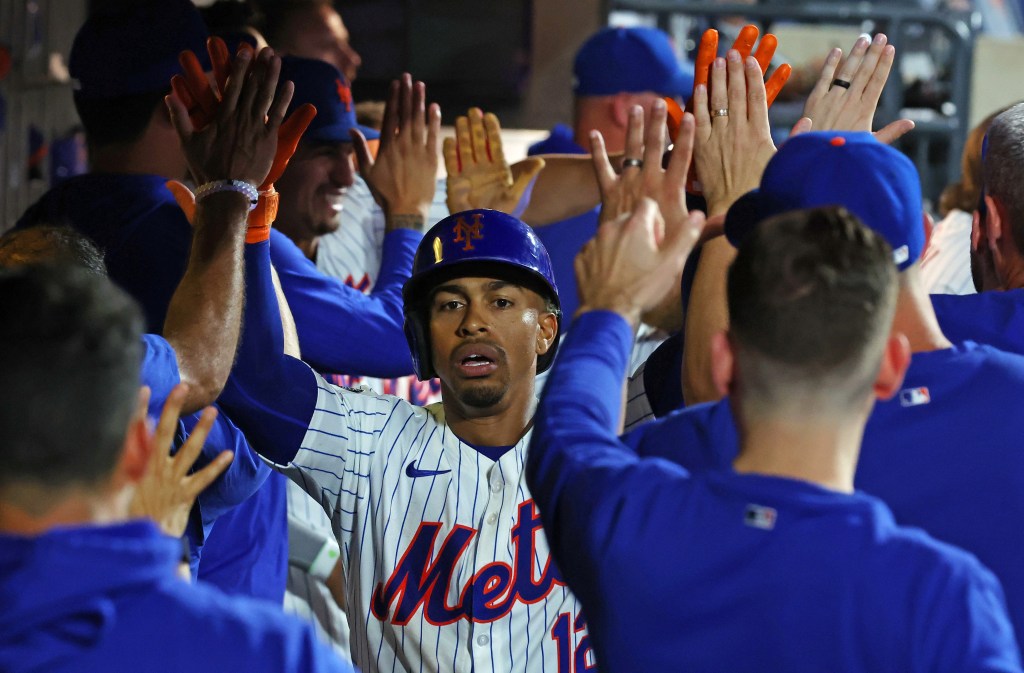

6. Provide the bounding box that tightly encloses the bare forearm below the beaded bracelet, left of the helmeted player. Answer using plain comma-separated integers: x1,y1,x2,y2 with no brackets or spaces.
163,192,249,413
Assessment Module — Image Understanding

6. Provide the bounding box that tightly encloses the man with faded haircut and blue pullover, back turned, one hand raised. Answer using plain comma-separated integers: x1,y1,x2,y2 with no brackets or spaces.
526,176,1021,673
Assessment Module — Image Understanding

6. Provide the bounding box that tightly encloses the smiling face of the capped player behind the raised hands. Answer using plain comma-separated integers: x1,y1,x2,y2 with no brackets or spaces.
275,142,355,239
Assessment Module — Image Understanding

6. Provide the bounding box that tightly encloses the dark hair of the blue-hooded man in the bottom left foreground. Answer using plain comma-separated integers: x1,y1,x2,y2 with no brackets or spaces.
0,264,142,489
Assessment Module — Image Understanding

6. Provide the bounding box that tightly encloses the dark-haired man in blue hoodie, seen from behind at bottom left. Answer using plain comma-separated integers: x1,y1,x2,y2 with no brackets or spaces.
0,262,351,673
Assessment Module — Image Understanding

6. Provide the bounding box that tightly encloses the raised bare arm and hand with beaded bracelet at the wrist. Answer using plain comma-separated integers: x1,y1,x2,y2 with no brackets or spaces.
163,45,291,414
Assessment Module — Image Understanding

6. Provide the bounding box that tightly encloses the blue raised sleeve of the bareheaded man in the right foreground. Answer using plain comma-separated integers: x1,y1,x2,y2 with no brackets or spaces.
526,311,688,611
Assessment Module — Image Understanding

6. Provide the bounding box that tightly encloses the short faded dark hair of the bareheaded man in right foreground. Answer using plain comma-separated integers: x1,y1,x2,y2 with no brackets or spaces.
727,207,897,407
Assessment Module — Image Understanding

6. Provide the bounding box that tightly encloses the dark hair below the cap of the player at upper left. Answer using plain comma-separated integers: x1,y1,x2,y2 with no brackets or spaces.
75,86,171,146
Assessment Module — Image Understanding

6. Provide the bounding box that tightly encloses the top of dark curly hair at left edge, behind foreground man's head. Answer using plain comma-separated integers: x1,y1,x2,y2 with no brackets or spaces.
0,224,106,276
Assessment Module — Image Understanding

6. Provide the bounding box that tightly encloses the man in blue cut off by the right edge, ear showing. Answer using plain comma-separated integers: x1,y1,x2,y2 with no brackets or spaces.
932,103,1024,353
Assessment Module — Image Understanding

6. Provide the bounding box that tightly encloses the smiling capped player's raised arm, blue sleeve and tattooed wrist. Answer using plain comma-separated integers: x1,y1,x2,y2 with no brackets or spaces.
280,75,440,378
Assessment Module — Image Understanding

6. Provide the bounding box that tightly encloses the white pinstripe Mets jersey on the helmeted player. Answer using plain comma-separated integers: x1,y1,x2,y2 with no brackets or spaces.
283,366,593,673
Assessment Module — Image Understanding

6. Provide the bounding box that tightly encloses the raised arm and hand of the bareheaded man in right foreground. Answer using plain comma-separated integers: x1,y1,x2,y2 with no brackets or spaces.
526,187,703,605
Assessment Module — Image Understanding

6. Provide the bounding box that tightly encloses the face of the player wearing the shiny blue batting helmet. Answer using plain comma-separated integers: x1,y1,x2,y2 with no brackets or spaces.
430,278,557,415
